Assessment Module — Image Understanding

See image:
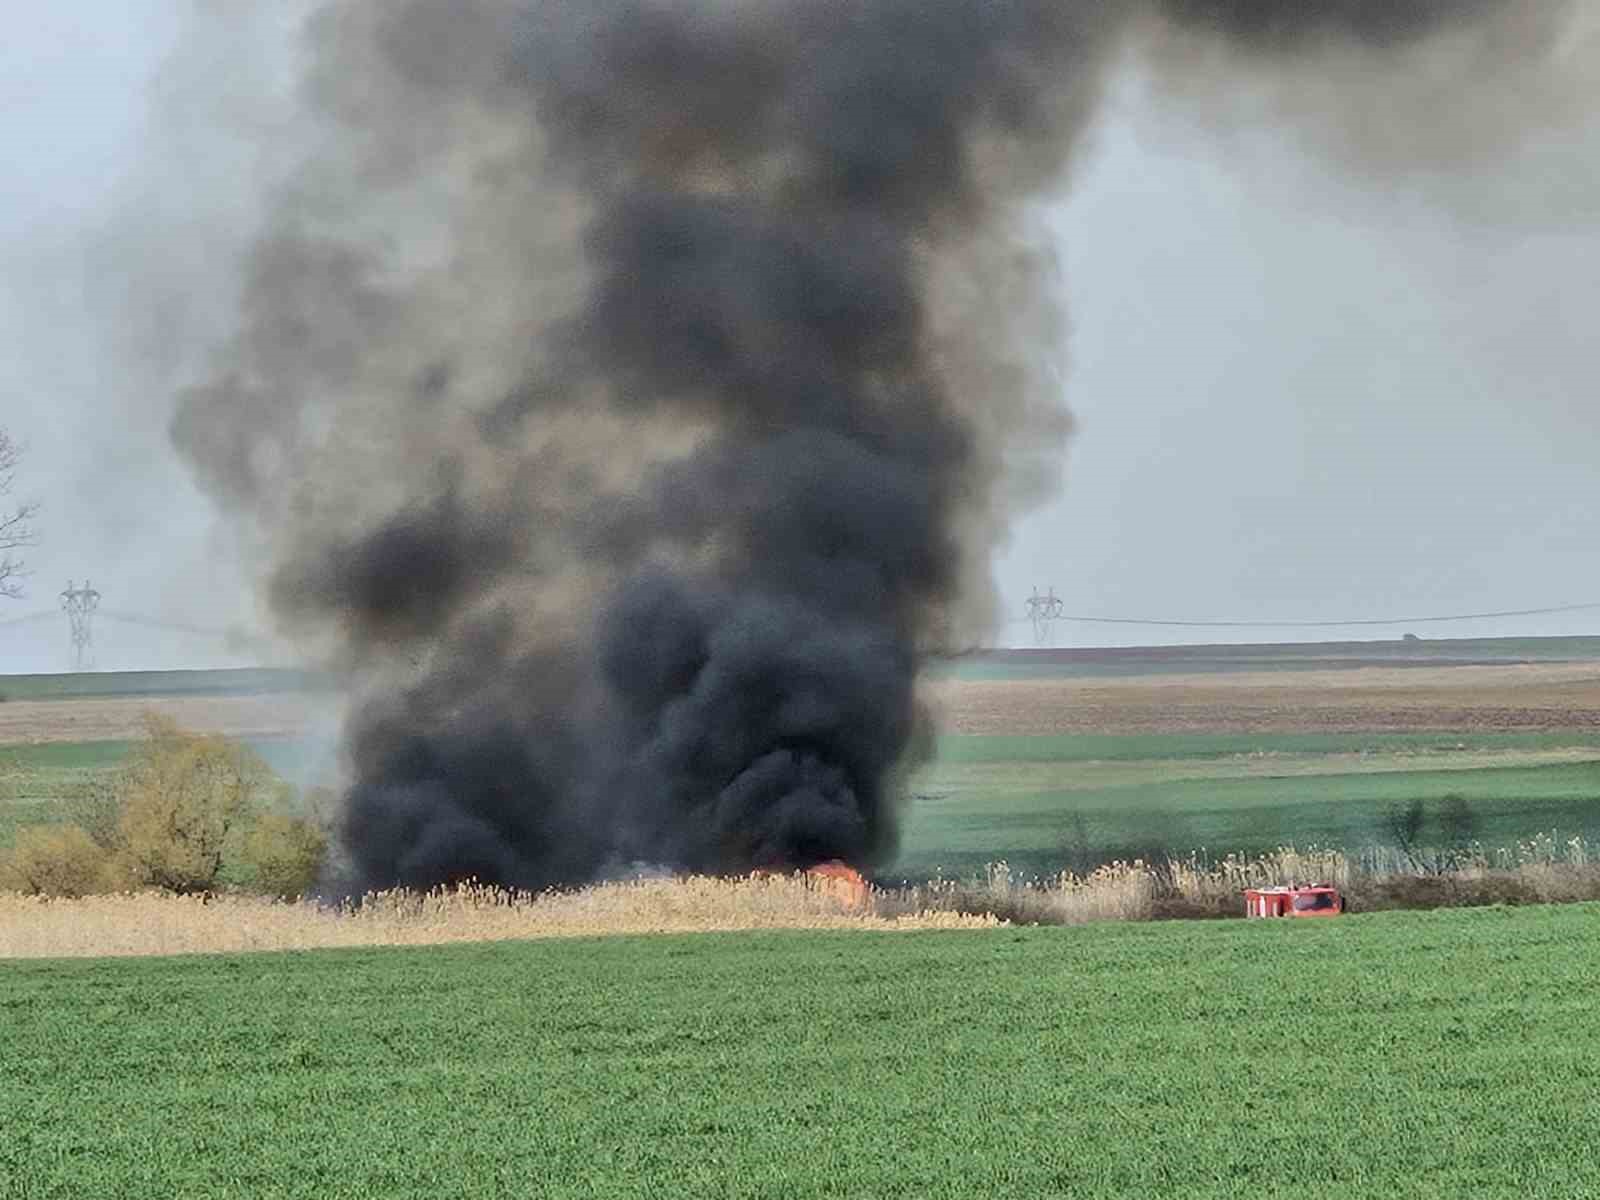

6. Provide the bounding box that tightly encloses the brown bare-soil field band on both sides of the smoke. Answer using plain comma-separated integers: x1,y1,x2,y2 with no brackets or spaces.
0,662,1600,746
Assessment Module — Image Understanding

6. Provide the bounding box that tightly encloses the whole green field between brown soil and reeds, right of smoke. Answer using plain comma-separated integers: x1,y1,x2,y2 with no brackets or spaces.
883,730,1600,878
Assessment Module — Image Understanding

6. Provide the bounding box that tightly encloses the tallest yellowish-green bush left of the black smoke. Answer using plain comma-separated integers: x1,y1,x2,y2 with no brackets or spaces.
117,715,283,893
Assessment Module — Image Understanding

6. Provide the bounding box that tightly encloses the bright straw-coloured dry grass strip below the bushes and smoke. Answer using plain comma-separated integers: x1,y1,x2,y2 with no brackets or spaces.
0,875,1000,958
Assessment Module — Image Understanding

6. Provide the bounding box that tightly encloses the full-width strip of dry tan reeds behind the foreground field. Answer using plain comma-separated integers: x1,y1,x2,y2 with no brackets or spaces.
12,835,1600,958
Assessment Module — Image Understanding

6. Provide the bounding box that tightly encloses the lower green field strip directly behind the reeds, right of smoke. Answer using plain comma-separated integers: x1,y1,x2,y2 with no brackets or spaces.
882,750,1600,880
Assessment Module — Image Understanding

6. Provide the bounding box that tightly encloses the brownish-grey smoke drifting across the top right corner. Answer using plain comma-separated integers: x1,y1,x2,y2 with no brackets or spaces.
1139,0,1580,180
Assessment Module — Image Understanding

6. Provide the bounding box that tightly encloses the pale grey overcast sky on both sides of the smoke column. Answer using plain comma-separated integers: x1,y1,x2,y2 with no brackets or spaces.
0,0,1600,674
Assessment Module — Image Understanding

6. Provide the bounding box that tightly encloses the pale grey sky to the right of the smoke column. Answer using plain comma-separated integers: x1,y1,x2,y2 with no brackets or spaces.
997,60,1600,645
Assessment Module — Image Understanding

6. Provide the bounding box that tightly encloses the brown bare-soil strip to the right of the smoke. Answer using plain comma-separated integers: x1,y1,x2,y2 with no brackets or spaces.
923,662,1600,734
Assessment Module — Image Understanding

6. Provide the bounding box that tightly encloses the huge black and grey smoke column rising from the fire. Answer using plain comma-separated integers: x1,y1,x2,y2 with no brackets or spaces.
173,0,1580,888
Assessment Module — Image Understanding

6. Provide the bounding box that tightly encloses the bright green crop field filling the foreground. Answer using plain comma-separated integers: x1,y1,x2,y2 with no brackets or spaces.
0,906,1600,1200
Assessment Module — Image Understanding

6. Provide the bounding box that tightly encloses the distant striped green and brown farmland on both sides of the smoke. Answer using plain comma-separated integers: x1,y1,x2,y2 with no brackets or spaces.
9,638,1600,880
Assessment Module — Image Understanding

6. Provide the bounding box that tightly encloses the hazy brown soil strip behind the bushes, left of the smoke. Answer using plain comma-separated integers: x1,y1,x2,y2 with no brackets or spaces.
0,691,338,746
